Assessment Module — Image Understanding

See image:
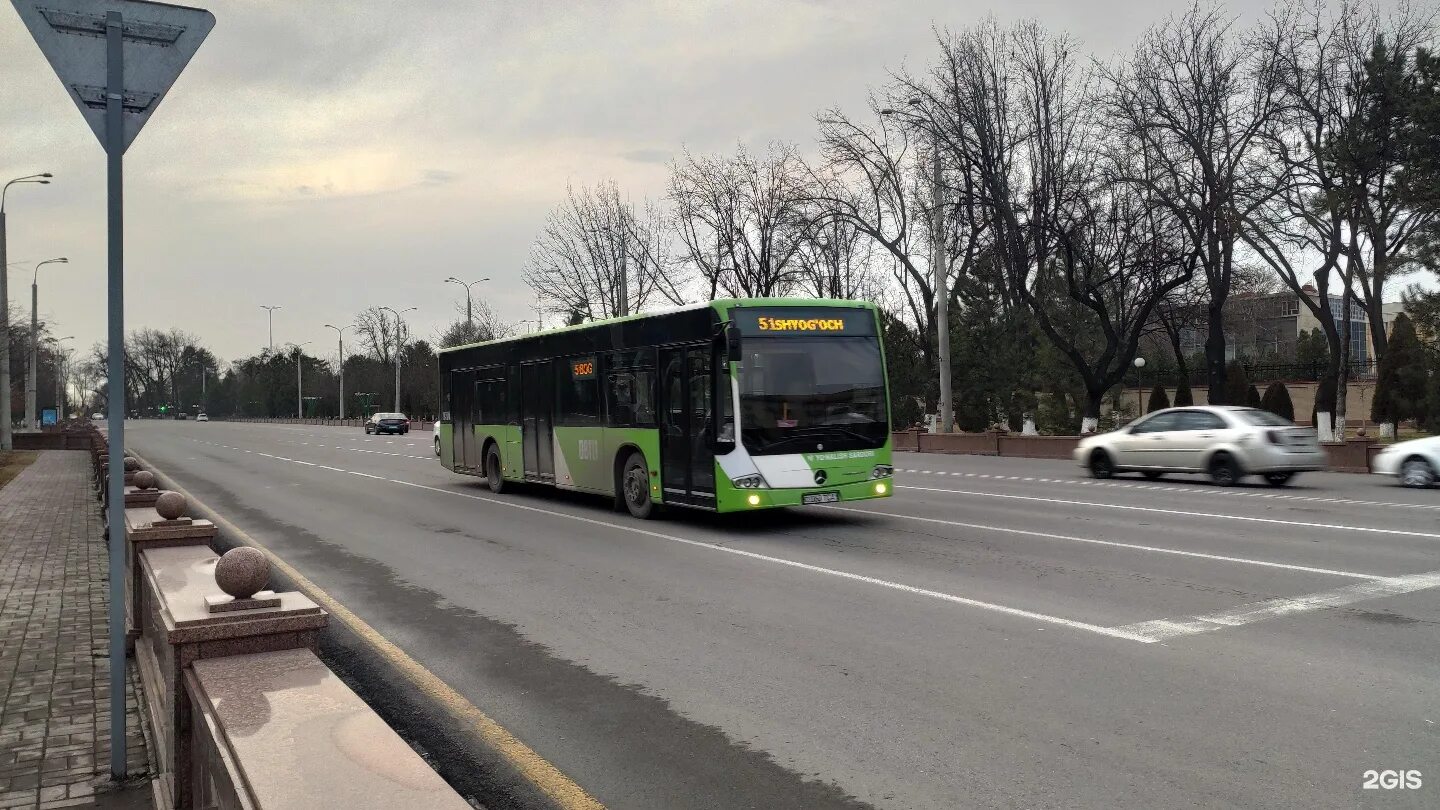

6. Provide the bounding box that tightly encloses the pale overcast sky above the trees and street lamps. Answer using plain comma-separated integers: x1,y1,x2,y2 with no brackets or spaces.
0,0,1284,360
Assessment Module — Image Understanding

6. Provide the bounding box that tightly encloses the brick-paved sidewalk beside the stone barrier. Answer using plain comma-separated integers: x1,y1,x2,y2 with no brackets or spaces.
0,451,150,810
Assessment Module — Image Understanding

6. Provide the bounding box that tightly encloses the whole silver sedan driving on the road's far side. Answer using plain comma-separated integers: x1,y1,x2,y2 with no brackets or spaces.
1074,405,1326,487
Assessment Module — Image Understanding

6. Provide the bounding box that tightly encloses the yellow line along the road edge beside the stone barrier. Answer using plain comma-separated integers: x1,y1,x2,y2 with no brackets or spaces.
131,451,605,810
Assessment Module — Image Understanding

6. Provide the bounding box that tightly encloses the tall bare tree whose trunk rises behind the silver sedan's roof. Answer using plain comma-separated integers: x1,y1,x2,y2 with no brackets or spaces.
1104,4,1279,404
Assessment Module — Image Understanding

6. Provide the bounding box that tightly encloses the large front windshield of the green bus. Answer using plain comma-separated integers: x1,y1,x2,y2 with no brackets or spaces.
740,336,890,455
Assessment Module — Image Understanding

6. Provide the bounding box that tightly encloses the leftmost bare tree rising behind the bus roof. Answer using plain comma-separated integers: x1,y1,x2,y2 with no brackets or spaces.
526,180,685,317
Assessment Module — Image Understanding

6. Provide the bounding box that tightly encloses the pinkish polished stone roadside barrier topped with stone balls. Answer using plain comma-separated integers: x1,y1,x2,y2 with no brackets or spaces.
84,430,471,810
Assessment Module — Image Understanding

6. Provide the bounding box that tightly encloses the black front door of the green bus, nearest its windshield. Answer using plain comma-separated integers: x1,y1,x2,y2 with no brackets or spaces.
660,346,716,506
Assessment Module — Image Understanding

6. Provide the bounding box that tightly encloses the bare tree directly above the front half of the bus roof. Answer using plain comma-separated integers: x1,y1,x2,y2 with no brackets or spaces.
670,144,808,298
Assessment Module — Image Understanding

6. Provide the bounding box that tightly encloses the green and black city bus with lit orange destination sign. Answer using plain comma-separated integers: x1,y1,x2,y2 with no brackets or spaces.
435,298,894,517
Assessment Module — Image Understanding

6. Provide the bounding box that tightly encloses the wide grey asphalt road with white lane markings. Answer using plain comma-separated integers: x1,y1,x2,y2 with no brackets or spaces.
128,421,1440,809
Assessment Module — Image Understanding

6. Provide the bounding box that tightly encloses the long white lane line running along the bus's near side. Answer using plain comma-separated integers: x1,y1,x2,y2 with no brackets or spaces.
188,435,1155,644
